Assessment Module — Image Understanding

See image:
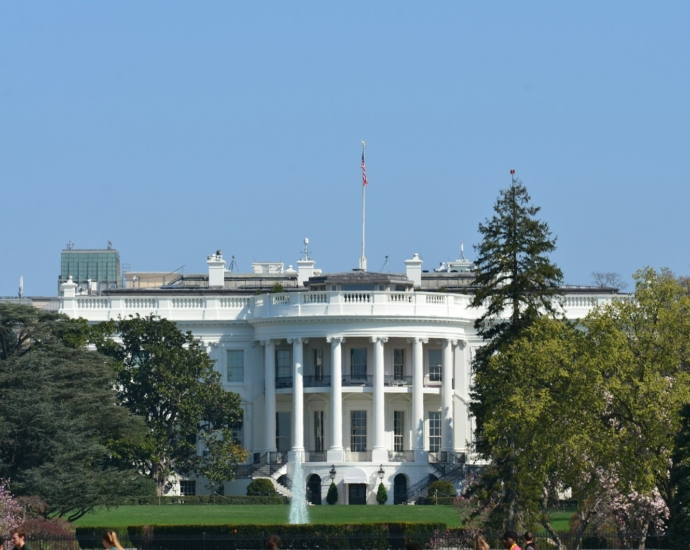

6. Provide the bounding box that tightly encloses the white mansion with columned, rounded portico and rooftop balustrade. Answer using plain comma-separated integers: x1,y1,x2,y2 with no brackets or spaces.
60,251,616,504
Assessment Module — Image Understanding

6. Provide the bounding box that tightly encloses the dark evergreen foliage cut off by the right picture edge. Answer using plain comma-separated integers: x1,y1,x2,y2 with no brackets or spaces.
668,405,690,550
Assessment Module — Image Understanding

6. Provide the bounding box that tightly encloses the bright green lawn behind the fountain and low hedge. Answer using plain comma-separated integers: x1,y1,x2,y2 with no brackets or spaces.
75,505,572,531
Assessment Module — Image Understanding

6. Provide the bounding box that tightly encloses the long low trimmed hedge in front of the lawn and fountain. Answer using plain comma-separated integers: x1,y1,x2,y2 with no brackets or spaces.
77,522,447,550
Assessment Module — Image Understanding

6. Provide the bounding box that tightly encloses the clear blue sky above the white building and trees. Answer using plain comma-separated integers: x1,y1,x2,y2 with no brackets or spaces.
0,0,690,295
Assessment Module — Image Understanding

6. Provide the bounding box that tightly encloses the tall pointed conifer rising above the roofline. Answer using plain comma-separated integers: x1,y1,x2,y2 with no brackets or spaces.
470,178,563,529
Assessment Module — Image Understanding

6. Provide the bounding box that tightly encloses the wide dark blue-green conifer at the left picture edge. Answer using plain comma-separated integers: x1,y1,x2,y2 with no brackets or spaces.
0,304,150,520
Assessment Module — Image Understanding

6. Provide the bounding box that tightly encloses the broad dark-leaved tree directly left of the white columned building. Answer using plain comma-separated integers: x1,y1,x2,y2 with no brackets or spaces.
91,316,246,494
